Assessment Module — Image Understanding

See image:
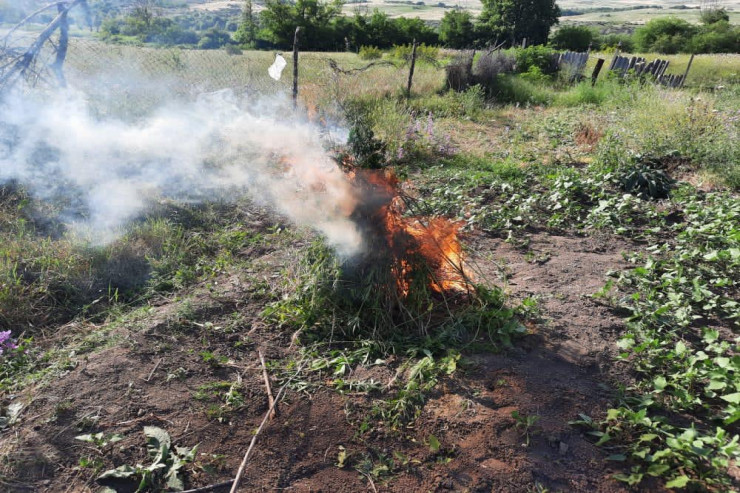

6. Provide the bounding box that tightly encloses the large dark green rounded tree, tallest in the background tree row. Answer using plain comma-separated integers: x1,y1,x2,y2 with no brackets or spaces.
476,0,560,45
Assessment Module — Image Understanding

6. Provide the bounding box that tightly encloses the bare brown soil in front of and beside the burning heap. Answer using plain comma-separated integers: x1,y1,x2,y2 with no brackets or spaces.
0,229,635,493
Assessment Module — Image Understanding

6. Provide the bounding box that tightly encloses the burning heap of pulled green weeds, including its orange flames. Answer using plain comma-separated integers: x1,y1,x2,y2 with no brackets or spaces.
266,156,506,340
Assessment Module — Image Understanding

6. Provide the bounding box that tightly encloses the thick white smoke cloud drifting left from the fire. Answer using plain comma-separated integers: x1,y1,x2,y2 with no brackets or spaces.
0,90,361,255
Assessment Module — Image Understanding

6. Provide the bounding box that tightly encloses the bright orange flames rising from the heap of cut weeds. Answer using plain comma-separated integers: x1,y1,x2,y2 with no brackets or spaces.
350,170,472,297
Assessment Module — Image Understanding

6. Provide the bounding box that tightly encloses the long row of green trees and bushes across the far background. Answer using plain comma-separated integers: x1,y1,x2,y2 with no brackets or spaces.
94,0,740,54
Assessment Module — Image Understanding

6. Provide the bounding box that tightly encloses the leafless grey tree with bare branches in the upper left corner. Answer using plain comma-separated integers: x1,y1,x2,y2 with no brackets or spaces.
0,0,92,93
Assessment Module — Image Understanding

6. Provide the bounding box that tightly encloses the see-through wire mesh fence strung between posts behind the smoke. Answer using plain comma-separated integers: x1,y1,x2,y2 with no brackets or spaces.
0,27,445,117
